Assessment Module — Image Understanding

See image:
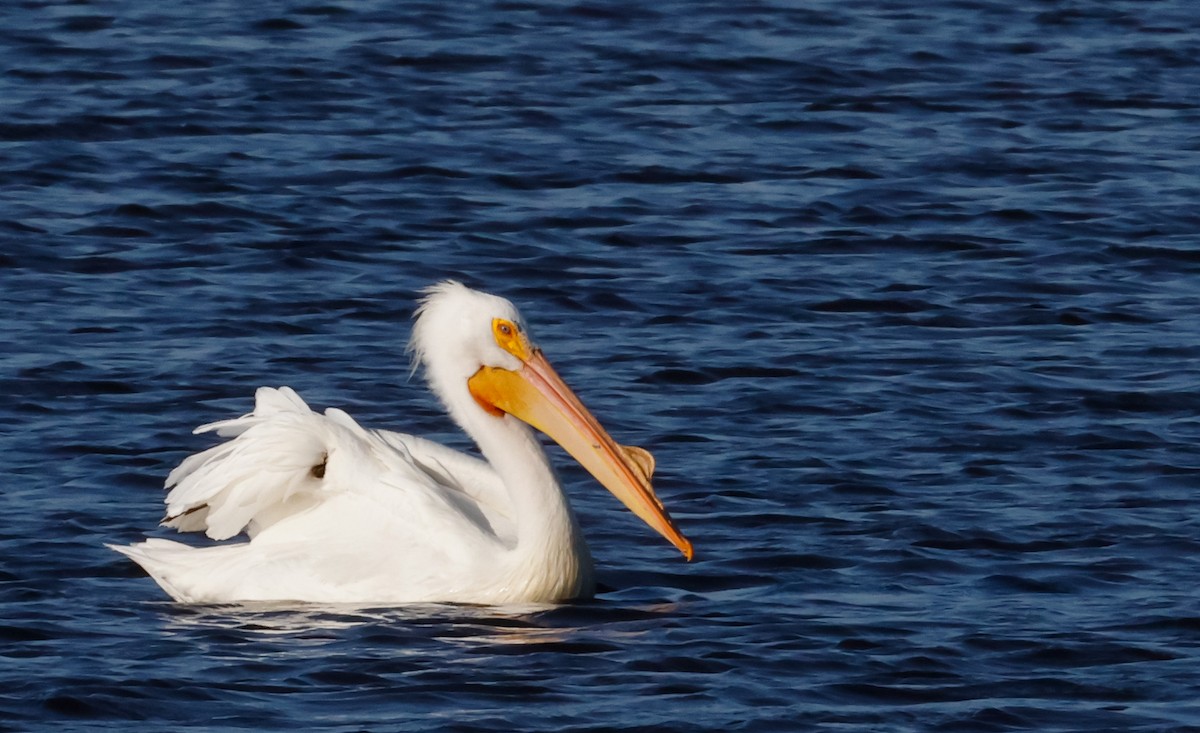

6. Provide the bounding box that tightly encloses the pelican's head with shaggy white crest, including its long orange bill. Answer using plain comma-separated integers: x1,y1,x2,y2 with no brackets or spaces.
409,281,692,560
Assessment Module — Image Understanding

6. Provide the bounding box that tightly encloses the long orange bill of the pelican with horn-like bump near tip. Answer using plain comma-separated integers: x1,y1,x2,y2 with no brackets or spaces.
468,344,692,560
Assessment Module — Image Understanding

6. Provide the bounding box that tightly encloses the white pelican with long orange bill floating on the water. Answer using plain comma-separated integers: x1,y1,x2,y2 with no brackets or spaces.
113,281,692,605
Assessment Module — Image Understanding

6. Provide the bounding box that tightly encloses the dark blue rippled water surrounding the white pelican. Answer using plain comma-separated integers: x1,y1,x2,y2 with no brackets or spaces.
0,0,1200,733
